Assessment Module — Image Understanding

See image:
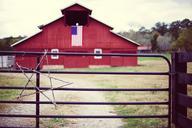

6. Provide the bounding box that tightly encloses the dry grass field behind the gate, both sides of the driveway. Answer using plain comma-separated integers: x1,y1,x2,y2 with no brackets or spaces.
0,55,192,128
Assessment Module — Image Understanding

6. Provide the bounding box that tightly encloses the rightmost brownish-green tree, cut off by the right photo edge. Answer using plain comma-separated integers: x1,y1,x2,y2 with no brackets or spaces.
172,28,192,51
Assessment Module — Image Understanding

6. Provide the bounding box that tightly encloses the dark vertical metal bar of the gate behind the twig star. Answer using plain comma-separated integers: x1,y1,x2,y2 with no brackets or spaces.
36,56,40,128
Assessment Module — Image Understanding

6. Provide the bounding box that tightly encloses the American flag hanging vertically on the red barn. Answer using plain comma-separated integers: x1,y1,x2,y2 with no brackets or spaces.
71,26,83,46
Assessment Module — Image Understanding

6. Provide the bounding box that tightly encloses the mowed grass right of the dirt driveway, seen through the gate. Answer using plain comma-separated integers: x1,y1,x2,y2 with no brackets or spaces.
91,58,168,128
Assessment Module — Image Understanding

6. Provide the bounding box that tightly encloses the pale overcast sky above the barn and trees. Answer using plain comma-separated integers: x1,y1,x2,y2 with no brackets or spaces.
0,0,192,38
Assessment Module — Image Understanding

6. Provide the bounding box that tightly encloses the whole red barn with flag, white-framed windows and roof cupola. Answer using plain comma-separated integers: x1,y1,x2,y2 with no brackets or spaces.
12,4,139,68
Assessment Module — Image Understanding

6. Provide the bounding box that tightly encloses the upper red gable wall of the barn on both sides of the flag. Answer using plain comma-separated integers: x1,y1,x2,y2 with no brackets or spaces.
16,18,137,50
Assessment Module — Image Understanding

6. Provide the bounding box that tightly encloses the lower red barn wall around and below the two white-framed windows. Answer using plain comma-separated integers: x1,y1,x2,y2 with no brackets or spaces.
16,49,137,68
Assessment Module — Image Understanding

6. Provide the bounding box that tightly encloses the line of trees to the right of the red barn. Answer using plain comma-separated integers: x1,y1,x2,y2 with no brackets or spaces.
119,19,192,52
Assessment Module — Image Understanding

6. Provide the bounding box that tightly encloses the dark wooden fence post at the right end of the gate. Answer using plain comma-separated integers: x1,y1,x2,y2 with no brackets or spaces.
171,52,187,128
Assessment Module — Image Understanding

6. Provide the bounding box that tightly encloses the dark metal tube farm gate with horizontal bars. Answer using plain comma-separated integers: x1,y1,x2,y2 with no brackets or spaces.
0,51,192,128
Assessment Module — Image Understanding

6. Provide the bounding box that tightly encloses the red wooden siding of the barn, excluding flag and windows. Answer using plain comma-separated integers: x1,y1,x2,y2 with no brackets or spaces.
14,3,138,68
